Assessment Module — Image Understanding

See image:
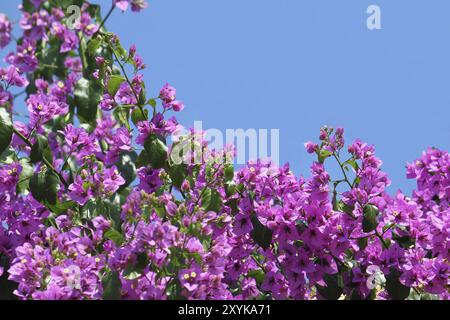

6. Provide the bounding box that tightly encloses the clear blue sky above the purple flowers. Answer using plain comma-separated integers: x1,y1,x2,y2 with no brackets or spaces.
0,0,450,192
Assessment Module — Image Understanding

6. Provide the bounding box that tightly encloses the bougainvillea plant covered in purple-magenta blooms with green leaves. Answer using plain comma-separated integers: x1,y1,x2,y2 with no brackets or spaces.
0,0,450,299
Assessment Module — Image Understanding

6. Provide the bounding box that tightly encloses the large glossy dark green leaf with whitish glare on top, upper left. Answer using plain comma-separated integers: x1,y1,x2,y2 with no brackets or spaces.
74,78,102,123
